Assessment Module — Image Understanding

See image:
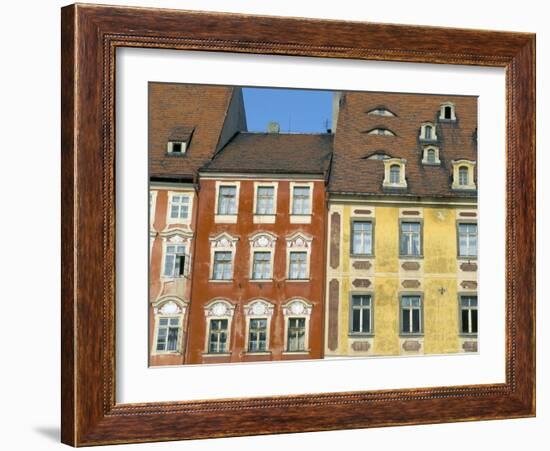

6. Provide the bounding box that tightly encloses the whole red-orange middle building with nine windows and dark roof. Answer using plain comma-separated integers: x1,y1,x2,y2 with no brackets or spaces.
186,132,332,363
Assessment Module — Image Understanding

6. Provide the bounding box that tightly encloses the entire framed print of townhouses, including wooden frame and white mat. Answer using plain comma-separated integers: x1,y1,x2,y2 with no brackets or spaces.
62,5,535,446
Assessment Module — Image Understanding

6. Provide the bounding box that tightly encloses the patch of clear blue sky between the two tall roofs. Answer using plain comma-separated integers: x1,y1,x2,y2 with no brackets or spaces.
243,88,332,133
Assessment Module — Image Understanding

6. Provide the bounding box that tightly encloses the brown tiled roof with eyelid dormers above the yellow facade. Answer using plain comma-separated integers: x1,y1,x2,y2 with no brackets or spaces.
329,92,477,197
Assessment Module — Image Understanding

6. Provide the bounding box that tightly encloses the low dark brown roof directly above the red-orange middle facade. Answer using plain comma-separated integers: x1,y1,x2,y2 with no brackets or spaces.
201,132,333,174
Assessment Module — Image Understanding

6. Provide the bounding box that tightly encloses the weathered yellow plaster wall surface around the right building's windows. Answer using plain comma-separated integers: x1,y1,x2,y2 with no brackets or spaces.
328,203,474,355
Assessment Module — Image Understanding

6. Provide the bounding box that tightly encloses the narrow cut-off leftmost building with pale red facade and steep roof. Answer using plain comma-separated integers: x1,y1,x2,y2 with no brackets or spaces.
149,83,246,366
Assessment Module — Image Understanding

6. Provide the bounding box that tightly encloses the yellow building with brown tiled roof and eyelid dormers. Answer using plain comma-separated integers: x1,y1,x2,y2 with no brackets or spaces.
325,93,478,357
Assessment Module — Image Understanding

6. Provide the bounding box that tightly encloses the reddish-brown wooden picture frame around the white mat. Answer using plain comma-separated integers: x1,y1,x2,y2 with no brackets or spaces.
61,4,535,446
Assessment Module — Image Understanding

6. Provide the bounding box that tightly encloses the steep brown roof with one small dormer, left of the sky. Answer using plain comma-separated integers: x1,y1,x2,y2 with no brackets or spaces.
149,83,246,178
